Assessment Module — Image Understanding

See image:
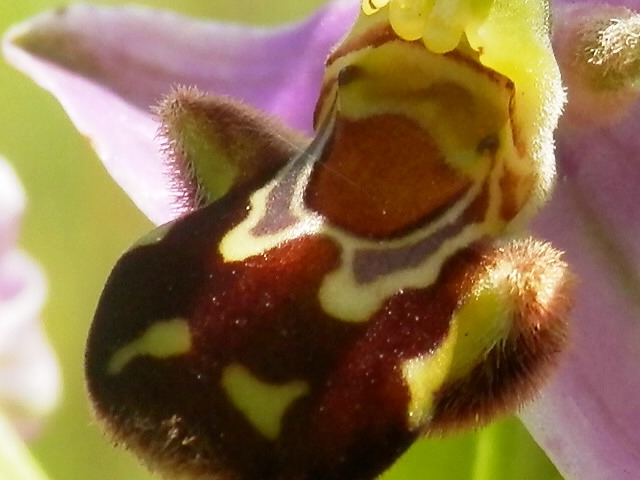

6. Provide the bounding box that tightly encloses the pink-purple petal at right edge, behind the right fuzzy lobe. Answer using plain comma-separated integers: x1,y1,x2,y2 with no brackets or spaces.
523,93,640,480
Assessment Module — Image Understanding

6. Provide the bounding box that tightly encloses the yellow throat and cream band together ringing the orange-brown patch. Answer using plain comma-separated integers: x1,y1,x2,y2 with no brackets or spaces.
219,15,539,322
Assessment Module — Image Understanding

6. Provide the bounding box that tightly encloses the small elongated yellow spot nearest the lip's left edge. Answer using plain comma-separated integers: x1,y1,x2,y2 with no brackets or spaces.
107,318,191,375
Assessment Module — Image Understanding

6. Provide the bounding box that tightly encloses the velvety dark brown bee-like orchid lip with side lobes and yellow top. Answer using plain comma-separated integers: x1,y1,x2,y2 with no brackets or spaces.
79,1,571,479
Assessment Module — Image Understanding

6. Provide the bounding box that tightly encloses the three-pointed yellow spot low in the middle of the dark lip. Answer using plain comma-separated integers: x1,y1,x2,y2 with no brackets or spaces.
221,363,309,440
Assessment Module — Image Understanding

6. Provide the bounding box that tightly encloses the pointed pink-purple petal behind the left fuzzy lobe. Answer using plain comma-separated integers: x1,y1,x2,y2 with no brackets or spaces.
4,0,359,223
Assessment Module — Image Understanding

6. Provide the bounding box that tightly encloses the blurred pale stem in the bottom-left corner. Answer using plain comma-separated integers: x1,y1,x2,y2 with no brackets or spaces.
0,414,49,480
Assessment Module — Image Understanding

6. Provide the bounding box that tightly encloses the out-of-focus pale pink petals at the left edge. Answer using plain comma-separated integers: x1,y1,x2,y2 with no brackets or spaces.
0,250,60,436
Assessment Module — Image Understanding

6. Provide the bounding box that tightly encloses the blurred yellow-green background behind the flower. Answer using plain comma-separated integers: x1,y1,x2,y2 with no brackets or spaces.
0,0,561,480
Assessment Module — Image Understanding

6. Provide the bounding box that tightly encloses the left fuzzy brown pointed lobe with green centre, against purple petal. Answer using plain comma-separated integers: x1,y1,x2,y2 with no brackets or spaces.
160,87,308,212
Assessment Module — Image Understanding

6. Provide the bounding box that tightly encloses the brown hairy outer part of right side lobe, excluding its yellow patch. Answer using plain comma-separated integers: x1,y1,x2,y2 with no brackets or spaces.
429,238,574,434
